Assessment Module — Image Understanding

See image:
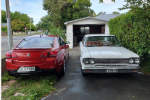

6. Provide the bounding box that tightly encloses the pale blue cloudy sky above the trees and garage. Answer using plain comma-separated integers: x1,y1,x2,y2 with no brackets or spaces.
1,0,128,25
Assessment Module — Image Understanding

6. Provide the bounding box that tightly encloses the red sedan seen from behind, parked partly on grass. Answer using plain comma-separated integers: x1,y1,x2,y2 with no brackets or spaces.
6,35,69,75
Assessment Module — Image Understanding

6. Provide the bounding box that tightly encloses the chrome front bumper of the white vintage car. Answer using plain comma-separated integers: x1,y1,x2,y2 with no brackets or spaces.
80,58,140,73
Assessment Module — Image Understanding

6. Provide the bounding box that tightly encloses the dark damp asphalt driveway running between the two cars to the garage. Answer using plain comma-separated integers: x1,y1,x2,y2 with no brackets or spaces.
42,47,150,100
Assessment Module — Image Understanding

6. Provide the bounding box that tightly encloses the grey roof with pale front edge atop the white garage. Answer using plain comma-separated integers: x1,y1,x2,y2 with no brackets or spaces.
64,14,120,25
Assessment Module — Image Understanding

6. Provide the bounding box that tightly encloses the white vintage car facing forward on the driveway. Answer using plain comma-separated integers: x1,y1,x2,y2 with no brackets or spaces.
80,34,140,76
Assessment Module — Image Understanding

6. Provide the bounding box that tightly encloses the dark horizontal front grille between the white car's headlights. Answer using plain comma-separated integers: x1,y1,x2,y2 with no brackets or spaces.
95,59,129,63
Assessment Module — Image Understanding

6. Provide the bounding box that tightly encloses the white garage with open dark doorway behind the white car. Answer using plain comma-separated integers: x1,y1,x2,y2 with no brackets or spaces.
64,14,120,48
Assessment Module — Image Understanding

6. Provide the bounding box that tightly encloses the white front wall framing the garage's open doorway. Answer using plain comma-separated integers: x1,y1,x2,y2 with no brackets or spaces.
66,18,109,49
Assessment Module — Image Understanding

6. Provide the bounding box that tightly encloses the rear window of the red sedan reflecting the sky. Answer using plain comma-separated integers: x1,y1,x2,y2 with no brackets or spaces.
17,37,54,48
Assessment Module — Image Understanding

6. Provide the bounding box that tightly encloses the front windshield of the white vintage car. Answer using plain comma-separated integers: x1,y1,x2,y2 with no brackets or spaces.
85,36,121,47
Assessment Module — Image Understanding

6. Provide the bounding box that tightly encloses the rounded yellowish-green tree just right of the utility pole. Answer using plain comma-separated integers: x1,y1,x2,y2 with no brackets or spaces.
11,19,25,31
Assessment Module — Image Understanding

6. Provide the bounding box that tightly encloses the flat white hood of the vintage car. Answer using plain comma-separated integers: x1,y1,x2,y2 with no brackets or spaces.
87,47,139,58
